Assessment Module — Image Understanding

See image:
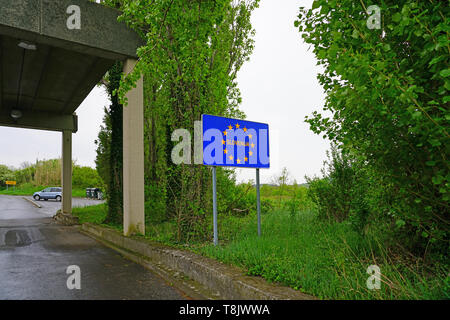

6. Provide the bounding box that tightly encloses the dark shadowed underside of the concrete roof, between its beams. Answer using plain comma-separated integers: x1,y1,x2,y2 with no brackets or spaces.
0,35,114,114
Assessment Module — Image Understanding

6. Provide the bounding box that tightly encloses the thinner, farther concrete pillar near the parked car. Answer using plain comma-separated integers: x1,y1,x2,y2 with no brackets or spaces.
61,130,72,213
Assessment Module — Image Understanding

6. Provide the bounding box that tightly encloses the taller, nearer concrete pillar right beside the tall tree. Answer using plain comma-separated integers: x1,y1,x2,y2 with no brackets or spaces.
123,59,145,236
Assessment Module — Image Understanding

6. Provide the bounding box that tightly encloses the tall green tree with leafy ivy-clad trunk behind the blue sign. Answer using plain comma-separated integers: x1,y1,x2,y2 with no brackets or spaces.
97,0,259,242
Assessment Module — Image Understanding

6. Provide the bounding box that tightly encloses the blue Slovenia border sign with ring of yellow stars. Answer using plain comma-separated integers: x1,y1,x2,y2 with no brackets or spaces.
202,114,270,168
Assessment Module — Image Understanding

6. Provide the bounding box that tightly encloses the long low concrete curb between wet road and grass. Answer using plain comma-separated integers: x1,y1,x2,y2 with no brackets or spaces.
81,223,316,300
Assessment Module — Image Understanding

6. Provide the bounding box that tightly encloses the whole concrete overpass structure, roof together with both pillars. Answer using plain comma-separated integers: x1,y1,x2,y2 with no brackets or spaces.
0,0,145,235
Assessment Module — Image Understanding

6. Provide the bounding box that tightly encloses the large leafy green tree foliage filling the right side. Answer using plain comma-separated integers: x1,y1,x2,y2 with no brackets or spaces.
295,0,450,254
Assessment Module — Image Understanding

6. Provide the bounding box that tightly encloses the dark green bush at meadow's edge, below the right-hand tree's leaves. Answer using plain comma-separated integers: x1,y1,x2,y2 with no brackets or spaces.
307,145,393,235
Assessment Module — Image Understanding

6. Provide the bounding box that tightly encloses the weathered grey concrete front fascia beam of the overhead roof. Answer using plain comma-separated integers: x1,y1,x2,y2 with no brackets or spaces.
0,0,143,60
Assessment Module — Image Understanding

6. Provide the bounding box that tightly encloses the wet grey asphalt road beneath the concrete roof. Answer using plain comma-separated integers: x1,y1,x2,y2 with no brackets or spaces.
0,195,187,300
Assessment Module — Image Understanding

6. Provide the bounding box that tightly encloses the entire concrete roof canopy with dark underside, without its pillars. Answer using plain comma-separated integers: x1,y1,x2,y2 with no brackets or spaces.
0,0,141,132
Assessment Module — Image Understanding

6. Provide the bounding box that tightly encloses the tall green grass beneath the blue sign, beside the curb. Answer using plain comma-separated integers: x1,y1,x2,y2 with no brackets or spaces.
199,211,449,299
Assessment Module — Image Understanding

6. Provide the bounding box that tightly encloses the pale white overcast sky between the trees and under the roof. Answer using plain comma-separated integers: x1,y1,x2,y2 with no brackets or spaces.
0,0,329,183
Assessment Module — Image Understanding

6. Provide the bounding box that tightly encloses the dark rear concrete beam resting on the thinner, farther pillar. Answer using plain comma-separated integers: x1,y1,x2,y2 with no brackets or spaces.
0,111,78,133
